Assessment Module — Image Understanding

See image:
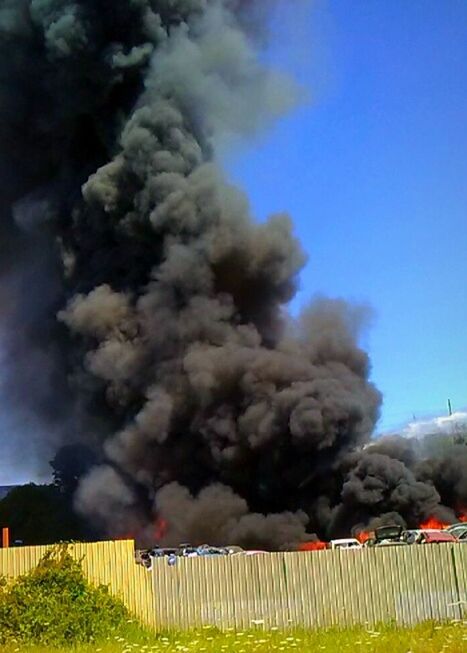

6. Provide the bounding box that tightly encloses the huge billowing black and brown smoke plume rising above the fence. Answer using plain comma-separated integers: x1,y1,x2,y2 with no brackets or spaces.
0,0,467,549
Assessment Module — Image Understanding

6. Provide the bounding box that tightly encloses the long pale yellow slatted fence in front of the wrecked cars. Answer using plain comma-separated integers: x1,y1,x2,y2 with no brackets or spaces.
0,541,467,630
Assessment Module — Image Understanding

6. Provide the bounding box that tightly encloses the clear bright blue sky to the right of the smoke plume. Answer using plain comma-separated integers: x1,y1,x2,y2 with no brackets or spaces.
227,0,467,430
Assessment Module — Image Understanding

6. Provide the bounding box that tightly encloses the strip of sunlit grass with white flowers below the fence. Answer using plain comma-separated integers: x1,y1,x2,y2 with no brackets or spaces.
1,621,467,653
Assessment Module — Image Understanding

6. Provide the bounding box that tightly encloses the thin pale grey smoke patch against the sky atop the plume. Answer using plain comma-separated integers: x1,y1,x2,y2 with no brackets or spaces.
143,3,298,145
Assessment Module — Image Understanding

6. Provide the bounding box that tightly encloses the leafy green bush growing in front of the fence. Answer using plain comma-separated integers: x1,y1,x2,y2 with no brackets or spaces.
0,545,129,646
